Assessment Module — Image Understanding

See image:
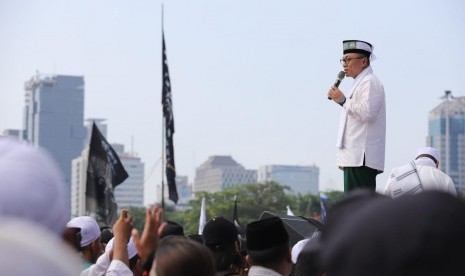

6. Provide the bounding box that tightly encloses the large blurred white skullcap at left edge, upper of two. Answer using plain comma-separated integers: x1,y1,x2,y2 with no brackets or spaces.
0,138,70,235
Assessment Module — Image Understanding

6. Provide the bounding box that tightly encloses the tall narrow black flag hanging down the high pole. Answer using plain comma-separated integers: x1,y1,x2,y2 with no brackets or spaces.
161,32,178,203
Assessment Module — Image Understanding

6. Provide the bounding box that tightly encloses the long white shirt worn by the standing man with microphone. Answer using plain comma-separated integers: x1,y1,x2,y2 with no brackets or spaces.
336,66,386,171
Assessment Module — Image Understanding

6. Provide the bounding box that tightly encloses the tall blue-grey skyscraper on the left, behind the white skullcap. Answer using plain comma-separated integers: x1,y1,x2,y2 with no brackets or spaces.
23,73,86,210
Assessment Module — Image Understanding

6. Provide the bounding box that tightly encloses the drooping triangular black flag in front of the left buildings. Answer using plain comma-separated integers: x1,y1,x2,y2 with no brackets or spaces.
86,123,128,225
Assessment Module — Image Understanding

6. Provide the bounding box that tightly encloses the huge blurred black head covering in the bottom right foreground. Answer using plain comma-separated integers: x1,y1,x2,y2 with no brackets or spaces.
321,191,465,276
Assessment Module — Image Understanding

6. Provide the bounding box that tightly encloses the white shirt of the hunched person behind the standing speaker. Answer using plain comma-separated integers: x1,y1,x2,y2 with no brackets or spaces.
384,157,457,197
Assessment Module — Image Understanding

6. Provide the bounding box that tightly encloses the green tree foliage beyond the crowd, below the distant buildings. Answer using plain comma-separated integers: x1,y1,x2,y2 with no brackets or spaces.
139,182,344,234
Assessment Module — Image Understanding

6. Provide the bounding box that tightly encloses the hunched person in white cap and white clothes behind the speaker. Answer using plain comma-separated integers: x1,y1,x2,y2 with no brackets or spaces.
384,147,457,198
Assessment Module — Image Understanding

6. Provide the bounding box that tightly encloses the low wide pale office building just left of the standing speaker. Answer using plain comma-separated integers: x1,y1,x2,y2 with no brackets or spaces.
258,165,320,194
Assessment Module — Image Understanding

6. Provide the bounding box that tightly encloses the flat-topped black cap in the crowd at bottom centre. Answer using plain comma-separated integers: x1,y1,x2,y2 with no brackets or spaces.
246,217,289,251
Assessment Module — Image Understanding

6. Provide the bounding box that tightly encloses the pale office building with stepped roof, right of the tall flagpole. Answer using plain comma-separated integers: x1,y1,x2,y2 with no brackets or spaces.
193,155,257,193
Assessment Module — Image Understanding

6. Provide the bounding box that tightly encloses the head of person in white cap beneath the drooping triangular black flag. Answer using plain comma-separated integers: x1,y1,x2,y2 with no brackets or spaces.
66,216,103,268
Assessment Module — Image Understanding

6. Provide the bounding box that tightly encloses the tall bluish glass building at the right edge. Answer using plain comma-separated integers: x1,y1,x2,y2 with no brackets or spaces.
426,91,465,193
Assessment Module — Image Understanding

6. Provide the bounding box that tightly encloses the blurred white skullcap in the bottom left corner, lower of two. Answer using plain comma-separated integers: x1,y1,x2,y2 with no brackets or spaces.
0,217,82,276
